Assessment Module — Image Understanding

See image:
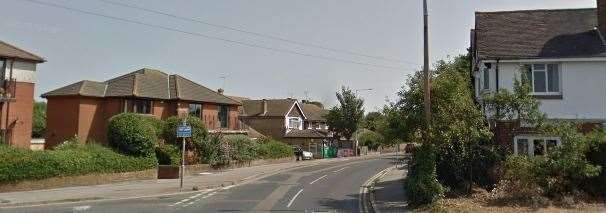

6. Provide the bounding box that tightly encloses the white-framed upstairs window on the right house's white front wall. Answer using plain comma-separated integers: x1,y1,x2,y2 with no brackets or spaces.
523,64,561,95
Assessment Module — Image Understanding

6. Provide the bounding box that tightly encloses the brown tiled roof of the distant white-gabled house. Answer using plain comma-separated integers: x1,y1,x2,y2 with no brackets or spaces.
242,98,297,116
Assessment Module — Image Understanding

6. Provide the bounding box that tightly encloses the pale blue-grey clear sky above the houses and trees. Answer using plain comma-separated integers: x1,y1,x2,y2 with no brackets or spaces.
0,0,596,111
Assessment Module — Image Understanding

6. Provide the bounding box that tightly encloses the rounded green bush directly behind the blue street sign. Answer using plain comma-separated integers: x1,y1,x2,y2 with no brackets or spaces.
162,116,208,146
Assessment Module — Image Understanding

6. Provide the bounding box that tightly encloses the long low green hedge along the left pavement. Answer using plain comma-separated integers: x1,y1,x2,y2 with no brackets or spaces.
0,144,157,183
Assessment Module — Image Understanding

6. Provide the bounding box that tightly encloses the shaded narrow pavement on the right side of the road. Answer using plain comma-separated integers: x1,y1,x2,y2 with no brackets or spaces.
370,156,409,213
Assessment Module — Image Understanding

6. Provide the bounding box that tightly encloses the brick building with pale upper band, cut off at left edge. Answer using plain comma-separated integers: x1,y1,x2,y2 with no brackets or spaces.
0,41,45,148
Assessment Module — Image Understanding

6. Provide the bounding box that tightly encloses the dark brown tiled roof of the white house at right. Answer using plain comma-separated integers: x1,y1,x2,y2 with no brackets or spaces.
474,8,606,59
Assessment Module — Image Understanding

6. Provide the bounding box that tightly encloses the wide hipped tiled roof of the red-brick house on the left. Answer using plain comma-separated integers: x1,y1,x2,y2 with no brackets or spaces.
42,69,240,105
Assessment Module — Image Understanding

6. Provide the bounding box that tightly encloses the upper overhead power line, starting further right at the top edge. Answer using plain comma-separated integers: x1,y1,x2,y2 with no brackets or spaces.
99,0,420,65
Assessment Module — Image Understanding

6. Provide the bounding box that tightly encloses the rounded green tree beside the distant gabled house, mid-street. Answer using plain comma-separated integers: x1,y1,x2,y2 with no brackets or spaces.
326,87,364,140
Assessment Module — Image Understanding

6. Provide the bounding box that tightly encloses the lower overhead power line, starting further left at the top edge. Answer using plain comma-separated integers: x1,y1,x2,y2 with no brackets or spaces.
21,0,416,71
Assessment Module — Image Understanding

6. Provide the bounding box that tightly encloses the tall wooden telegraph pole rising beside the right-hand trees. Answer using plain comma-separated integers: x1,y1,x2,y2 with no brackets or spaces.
423,0,431,143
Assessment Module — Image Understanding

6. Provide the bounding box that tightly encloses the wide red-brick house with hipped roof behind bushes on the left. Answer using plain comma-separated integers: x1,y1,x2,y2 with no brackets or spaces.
42,68,245,148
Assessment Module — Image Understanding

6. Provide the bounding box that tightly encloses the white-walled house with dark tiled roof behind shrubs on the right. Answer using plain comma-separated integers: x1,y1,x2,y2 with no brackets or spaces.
470,0,606,156
